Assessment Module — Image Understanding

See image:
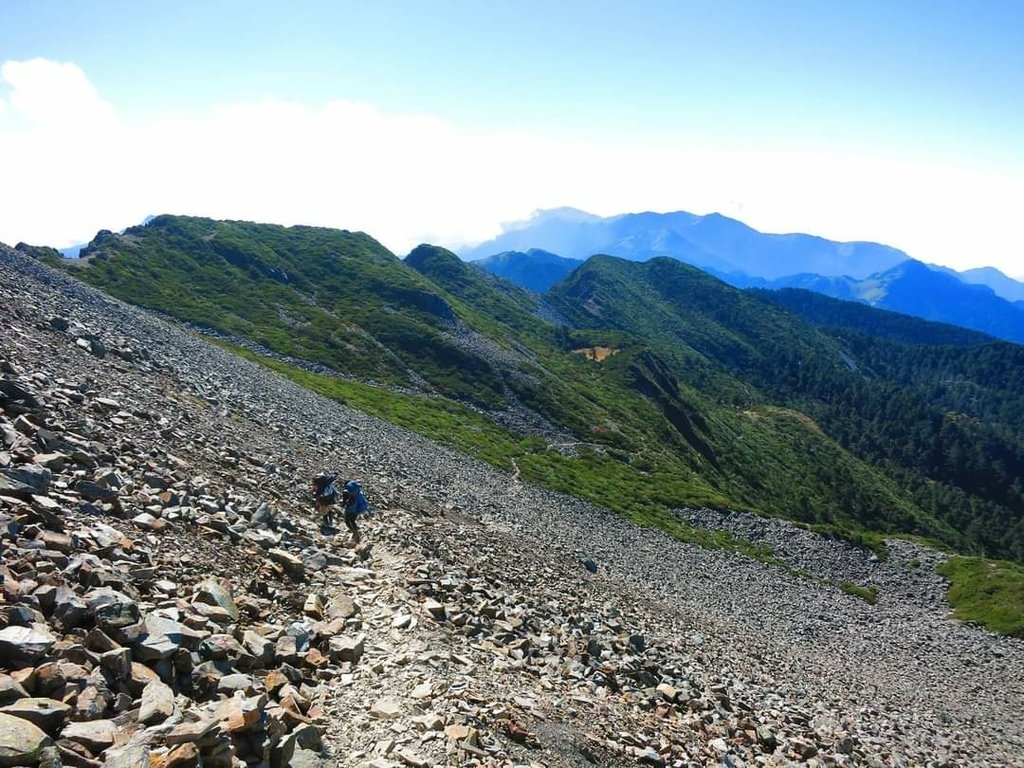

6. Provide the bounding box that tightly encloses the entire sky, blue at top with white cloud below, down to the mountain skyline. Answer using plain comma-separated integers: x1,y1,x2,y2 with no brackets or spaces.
0,0,1024,278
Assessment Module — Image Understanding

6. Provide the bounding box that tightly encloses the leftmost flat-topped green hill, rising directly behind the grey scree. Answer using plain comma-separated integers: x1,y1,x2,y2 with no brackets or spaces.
70,216,503,404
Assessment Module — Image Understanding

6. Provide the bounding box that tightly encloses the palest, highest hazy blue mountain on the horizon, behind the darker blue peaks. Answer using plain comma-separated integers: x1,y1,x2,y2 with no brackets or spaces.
460,208,908,280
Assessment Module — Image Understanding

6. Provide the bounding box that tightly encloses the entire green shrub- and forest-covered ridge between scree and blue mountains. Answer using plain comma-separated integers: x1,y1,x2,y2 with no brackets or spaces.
32,216,1024,560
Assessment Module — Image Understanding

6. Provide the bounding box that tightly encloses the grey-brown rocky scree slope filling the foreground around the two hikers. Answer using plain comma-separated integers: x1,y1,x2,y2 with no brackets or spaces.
0,241,1024,768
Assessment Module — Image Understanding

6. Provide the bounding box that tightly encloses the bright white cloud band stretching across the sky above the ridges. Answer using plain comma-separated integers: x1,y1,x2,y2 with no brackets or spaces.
0,59,1024,273
